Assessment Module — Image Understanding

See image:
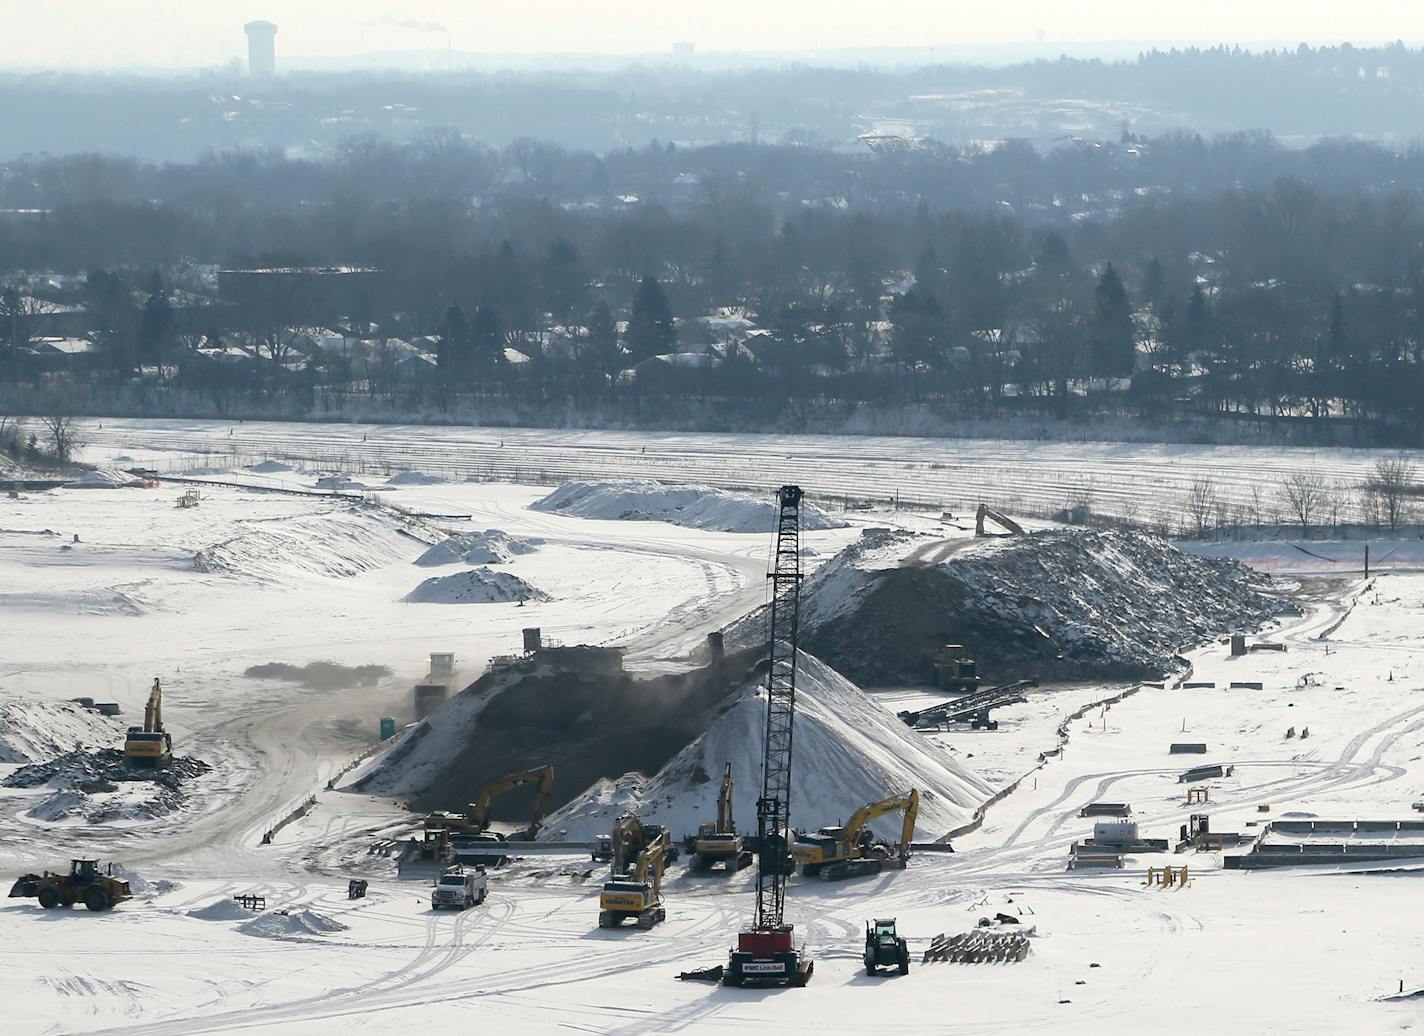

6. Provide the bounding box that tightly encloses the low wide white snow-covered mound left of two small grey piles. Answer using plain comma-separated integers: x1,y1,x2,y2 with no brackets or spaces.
194,507,434,582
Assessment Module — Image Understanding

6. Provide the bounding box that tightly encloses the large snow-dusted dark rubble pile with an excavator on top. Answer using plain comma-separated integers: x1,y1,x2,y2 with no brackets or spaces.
732,529,1277,686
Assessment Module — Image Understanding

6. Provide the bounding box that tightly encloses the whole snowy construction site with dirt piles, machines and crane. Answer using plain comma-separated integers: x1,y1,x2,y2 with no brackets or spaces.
0,430,1424,1035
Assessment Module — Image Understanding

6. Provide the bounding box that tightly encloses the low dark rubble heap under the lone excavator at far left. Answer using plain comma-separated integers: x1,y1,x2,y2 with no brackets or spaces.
0,749,212,824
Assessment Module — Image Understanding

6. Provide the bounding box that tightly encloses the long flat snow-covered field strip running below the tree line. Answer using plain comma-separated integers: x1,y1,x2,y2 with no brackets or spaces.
84,418,1424,529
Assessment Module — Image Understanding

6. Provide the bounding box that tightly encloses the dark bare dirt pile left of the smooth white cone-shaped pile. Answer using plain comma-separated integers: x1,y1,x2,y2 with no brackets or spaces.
352,648,746,820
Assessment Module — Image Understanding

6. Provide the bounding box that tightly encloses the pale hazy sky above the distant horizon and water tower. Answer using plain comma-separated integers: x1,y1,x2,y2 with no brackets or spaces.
0,0,1424,68
